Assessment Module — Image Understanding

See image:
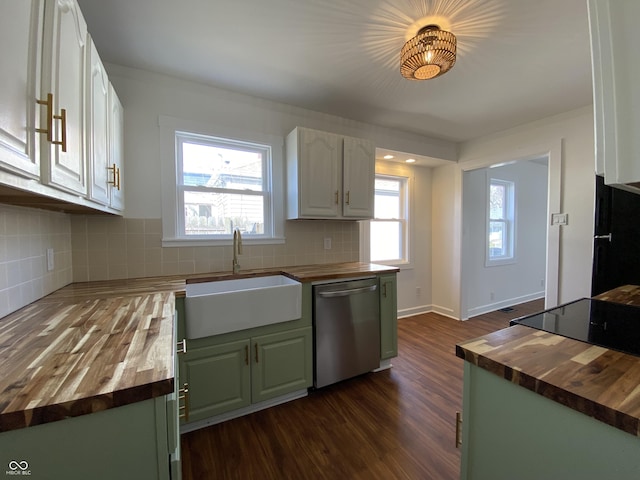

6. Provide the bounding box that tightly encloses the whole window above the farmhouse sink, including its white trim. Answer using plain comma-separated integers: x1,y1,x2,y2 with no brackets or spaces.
159,117,284,246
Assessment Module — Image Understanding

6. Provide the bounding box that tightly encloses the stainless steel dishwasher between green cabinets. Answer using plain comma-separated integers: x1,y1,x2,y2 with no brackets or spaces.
313,277,380,388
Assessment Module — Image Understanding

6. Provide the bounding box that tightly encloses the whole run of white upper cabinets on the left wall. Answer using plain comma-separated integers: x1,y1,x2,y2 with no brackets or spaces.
0,0,124,213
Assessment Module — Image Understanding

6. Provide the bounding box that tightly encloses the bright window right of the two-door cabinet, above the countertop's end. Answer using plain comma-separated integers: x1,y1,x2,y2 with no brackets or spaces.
369,175,408,263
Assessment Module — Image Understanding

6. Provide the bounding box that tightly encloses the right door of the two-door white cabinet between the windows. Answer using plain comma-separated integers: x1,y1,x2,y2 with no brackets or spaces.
342,137,376,218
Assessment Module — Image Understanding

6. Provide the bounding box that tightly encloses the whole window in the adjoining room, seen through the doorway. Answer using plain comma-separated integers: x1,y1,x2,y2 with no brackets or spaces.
487,178,515,265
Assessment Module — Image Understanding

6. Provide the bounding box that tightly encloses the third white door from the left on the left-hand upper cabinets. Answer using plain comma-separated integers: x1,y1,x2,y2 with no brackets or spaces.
87,41,110,205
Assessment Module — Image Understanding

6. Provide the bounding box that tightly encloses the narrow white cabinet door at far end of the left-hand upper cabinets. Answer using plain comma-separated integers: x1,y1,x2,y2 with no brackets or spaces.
107,84,124,211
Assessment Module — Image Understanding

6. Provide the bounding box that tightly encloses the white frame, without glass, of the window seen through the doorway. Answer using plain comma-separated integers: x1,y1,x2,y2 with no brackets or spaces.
485,176,516,267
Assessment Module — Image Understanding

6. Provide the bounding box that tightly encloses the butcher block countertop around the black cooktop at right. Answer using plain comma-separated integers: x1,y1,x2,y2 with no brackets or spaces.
456,285,640,436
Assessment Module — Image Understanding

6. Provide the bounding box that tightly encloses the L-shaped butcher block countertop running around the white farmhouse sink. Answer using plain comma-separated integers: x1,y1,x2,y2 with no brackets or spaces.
0,262,398,432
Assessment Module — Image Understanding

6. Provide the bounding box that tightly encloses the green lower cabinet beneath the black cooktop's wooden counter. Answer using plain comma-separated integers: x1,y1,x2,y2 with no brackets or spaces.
462,362,640,480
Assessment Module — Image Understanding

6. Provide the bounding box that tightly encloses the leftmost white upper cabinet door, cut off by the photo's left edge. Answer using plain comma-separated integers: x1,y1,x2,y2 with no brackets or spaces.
0,0,46,178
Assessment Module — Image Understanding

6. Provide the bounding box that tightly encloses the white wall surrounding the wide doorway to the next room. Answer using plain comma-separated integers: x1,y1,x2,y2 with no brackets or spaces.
432,106,595,318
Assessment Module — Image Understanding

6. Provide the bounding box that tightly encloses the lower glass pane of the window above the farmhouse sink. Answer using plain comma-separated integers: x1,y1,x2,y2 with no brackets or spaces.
184,191,264,235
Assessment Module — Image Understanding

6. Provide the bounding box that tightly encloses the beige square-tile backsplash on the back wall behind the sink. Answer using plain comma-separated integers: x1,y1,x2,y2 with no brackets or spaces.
71,215,359,282
